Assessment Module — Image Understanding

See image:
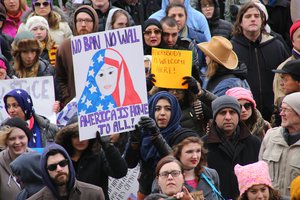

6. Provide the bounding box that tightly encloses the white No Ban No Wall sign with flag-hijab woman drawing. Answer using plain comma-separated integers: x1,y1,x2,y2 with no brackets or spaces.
72,26,148,140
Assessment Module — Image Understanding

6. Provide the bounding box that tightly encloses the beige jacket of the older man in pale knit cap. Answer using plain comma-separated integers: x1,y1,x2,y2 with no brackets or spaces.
259,127,300,196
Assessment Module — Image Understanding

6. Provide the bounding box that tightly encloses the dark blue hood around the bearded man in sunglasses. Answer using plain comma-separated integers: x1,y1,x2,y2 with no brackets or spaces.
40,143,76,199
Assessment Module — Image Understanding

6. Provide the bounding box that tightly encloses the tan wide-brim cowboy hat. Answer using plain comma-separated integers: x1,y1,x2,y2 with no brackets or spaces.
198,36,238,69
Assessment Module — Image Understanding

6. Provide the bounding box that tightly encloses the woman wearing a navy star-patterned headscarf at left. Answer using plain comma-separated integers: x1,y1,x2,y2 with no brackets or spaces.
3,89,58,148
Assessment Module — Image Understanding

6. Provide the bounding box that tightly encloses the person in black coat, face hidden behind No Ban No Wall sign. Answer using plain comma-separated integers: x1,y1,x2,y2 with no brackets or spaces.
56,120,127,200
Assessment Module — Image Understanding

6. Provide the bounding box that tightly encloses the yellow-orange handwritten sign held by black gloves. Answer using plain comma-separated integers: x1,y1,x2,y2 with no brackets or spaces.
151,48,193,89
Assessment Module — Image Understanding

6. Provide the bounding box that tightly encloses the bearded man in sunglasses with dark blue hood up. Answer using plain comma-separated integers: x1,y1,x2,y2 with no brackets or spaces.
29,144,105,200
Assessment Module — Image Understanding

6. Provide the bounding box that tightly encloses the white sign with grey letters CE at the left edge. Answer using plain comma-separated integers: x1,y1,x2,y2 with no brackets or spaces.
0,76,56,124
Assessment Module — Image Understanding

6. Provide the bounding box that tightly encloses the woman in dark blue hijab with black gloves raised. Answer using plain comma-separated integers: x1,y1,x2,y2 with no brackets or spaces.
124,92,181,199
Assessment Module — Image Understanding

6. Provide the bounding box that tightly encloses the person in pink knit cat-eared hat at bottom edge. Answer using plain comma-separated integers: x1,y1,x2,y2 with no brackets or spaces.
234,161,289,200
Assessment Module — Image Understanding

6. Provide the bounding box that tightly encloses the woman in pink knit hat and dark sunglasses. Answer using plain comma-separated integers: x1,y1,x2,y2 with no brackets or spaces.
226,87,271,140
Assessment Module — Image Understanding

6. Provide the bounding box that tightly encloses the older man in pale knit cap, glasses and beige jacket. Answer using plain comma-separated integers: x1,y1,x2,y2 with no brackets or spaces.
259,92,300,196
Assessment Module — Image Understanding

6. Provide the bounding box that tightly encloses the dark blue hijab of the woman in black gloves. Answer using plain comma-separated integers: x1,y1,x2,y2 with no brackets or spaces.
141,91,181,161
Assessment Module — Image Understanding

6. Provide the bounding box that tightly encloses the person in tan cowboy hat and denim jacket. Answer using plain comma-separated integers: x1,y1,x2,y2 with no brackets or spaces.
198,36,250,96
